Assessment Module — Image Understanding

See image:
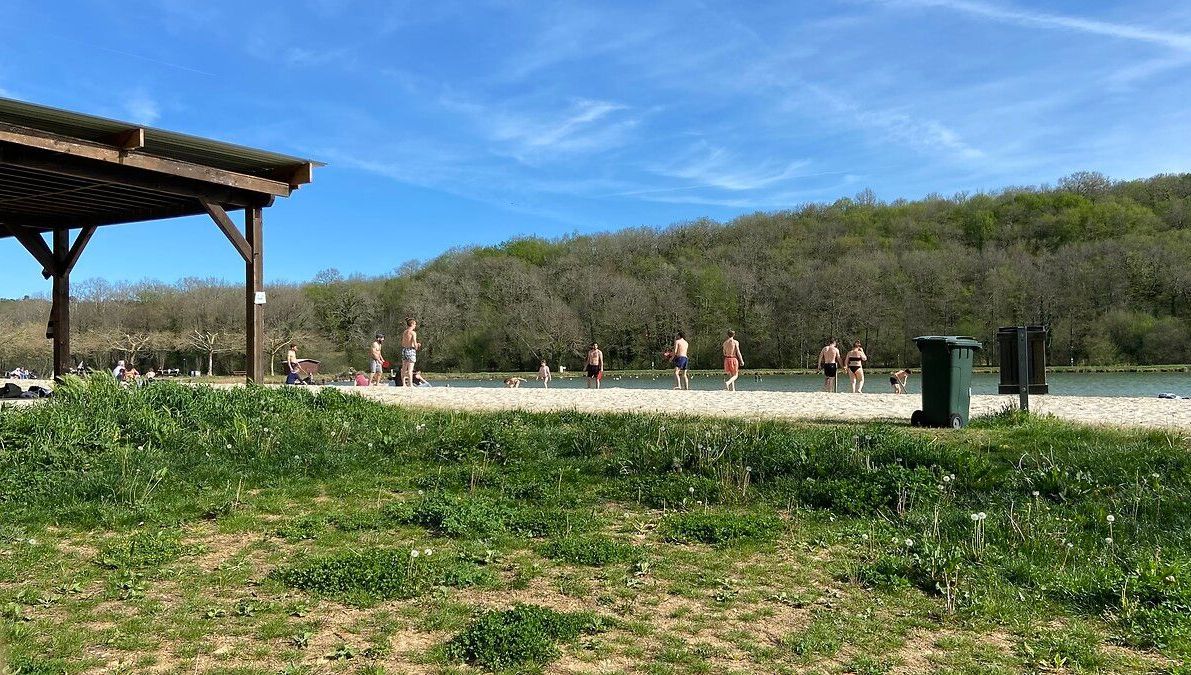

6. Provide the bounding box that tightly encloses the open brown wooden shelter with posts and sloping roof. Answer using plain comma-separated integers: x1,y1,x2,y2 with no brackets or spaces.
0,98,322,382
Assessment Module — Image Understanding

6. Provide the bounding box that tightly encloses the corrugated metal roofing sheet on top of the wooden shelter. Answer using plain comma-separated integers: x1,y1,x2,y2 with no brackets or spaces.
0,96,323,175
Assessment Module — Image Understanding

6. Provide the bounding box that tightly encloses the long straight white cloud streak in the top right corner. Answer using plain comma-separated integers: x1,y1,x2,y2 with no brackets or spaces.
892,0,1191,52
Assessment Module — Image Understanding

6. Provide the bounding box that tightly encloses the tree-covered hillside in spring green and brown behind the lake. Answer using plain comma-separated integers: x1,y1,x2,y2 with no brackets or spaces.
0,174,1191,371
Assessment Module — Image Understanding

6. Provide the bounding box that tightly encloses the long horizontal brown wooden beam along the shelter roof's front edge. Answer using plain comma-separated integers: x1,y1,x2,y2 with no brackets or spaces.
0,123,292,196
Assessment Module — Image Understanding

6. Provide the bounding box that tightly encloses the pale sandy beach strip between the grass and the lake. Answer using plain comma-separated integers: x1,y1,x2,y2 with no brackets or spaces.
345,387,1191,429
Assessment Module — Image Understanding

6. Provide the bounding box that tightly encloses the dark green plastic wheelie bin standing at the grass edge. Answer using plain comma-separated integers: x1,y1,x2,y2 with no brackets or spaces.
910,336,984,429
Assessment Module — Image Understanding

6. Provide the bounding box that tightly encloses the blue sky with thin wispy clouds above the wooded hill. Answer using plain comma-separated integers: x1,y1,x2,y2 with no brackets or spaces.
0,0,1191,296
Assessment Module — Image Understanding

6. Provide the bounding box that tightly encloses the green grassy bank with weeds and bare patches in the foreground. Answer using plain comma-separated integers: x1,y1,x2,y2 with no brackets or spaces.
0,379,1191,673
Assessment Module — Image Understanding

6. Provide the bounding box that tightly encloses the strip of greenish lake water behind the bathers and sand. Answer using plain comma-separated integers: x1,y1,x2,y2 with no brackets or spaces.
369,370,1191,398
